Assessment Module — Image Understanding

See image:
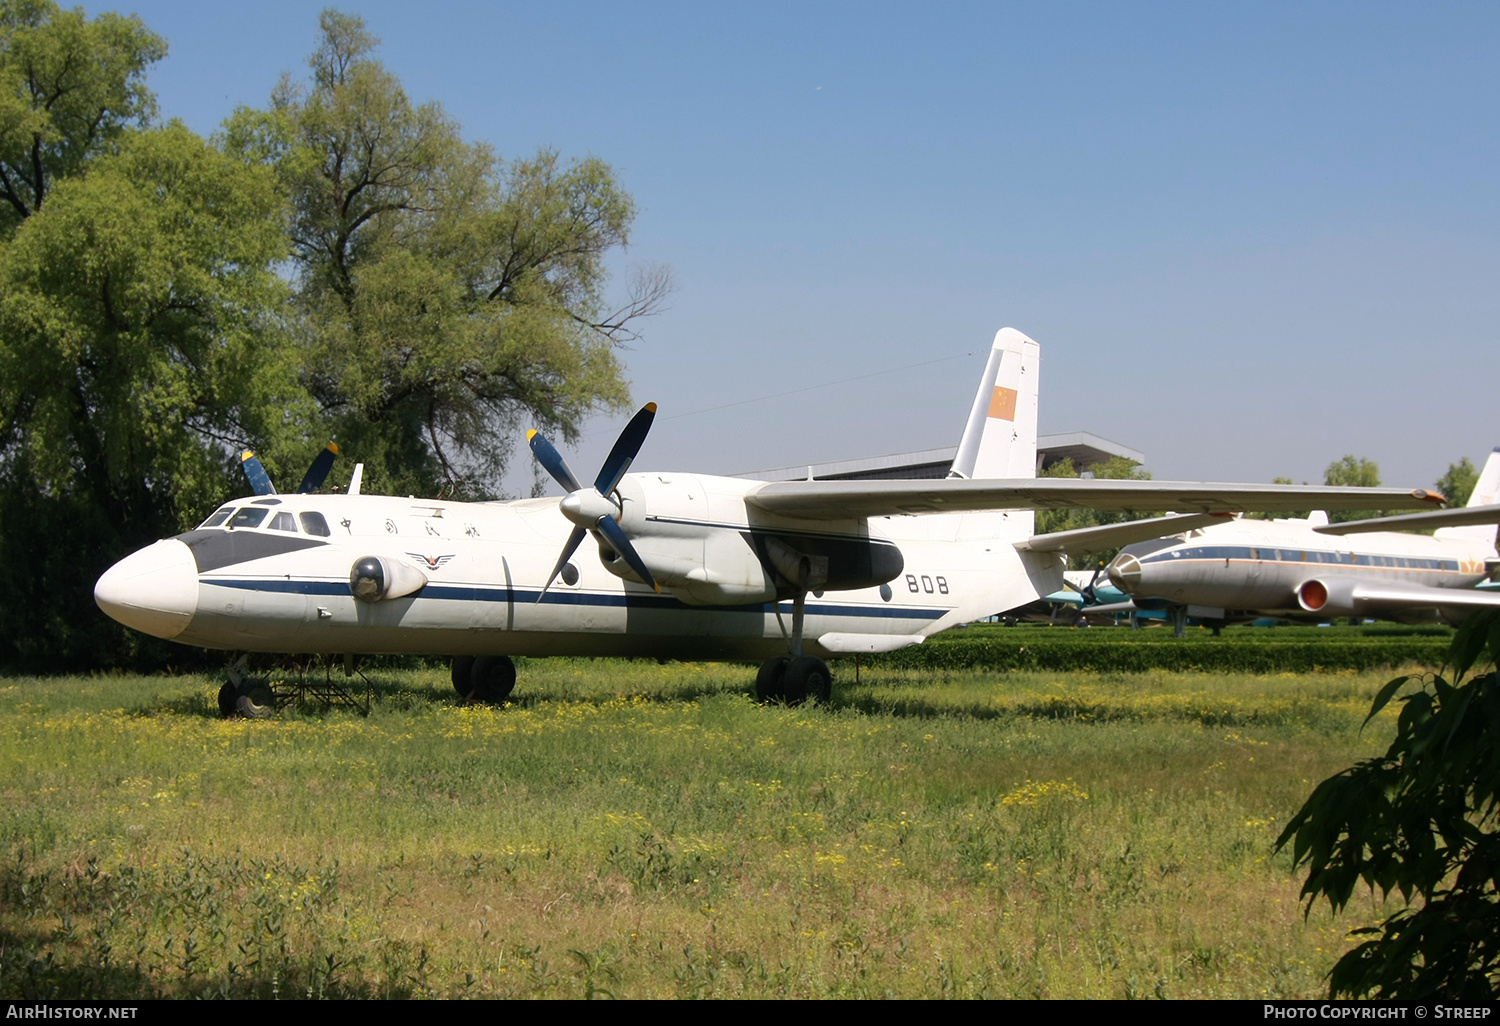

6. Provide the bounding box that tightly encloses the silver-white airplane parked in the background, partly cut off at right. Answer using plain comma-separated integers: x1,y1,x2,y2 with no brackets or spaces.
1104,449,1500,635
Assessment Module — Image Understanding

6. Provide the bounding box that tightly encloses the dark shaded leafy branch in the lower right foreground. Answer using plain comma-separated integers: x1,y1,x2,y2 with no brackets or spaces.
1277,611,1500,1001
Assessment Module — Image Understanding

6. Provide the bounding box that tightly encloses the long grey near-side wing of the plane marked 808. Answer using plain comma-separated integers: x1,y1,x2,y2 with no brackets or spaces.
746,477,1443,521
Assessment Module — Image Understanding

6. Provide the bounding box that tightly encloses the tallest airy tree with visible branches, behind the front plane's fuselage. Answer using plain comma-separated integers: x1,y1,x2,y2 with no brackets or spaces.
227,11,669,495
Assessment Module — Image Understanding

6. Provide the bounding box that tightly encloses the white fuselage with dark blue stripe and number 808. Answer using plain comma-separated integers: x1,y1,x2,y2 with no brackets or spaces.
95,474,1061,660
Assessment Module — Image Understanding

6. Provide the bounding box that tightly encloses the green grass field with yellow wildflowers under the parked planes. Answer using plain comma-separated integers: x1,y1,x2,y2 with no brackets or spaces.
0,660,1428,998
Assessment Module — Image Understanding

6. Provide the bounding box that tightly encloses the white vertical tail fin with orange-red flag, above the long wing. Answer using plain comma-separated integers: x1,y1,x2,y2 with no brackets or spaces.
948,329,1041,479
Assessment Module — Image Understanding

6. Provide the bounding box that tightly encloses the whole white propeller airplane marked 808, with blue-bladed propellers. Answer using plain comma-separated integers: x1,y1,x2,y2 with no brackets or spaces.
95,329,1440,713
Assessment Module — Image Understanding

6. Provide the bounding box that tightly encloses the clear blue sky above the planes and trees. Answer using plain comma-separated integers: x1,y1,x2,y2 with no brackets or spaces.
89,2,1500,491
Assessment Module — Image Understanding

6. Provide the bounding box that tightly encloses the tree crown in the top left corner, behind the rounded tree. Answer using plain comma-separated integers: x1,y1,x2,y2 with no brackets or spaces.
0,0,167,237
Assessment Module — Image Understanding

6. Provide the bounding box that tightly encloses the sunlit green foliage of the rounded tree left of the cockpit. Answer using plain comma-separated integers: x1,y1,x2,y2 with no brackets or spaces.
0,125,299,533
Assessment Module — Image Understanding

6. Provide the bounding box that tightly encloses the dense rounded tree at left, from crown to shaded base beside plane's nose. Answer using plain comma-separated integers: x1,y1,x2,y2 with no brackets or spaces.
0,125,306,666
